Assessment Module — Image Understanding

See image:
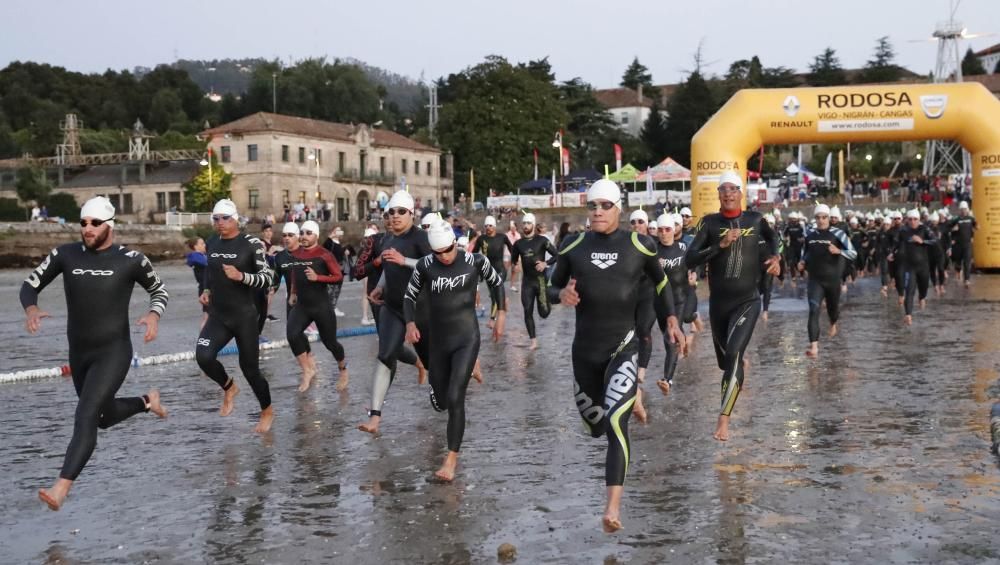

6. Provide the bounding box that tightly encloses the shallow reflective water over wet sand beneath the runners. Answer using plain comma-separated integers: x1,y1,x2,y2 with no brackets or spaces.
0,265,1000,563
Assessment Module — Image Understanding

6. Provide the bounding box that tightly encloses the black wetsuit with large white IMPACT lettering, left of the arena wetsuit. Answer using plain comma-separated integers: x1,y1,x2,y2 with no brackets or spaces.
403,250,507,451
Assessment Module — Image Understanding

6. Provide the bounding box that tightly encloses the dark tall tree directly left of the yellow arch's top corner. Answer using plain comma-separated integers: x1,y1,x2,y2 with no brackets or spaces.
666,71,717,167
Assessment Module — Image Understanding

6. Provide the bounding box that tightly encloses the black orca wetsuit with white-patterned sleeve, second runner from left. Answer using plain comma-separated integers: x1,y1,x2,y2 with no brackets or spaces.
195,234,273,410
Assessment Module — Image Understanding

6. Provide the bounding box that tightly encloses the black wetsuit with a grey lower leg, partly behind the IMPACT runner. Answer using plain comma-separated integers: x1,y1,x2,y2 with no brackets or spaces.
369,226,431,416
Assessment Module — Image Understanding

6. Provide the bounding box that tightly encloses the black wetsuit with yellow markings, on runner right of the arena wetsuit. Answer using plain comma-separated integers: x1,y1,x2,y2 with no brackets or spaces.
687,212,780,416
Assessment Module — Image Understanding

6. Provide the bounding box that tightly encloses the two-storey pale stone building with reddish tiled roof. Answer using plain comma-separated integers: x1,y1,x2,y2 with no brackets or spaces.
201,112,453,221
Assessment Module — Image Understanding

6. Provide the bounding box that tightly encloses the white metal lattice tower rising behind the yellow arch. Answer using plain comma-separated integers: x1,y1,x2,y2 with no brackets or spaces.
924,2,972,176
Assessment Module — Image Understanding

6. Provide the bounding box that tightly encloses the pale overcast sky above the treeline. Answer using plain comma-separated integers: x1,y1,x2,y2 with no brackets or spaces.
0,0,1000,88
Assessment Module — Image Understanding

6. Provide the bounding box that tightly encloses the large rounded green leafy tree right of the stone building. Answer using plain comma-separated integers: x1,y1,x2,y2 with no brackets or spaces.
436,55,575,194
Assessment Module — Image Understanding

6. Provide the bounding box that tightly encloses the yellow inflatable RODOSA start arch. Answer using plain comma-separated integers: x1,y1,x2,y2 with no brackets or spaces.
691,83,1000,269
